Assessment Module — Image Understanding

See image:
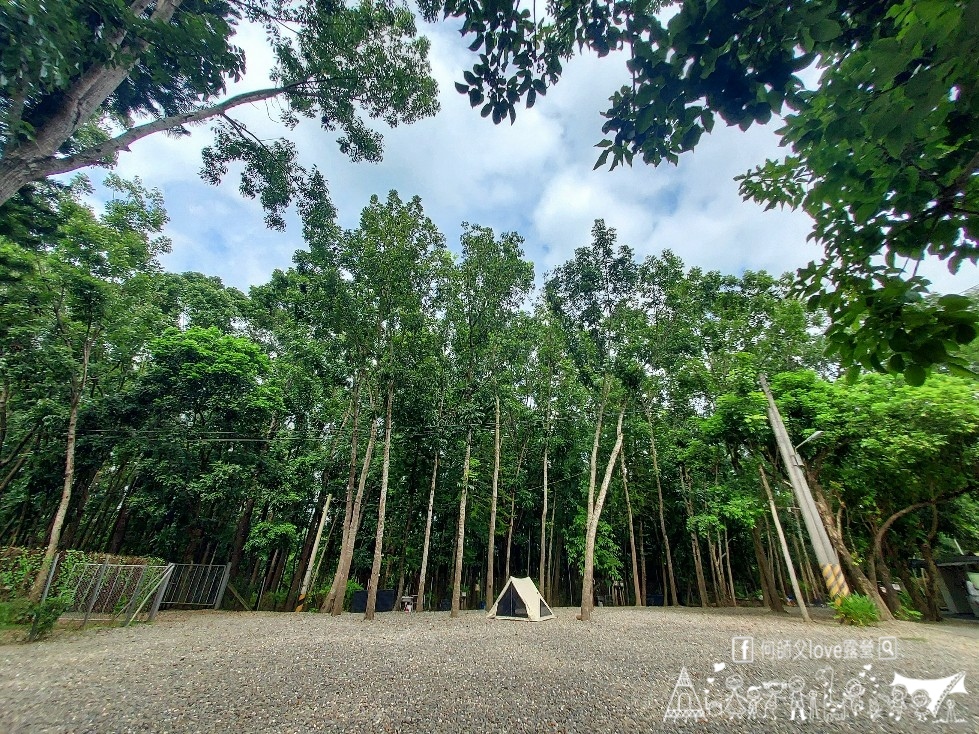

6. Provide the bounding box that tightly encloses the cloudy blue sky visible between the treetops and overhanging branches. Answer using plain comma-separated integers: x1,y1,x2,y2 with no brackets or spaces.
88,15,979,292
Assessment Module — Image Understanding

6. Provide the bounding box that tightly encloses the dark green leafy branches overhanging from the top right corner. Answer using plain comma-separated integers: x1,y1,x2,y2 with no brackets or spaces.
444,0,979,376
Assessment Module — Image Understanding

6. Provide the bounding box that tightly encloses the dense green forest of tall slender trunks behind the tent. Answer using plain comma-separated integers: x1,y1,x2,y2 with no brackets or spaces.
0,176,979,618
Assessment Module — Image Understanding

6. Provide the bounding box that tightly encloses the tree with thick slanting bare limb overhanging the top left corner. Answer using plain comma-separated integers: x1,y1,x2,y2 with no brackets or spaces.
0,0,438,221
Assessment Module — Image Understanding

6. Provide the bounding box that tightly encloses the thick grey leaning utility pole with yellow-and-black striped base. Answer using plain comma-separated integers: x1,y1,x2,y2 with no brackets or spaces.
758,375,850,599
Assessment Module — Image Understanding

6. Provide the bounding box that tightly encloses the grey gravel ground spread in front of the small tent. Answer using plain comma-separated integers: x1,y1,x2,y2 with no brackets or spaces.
0,608,979,734
